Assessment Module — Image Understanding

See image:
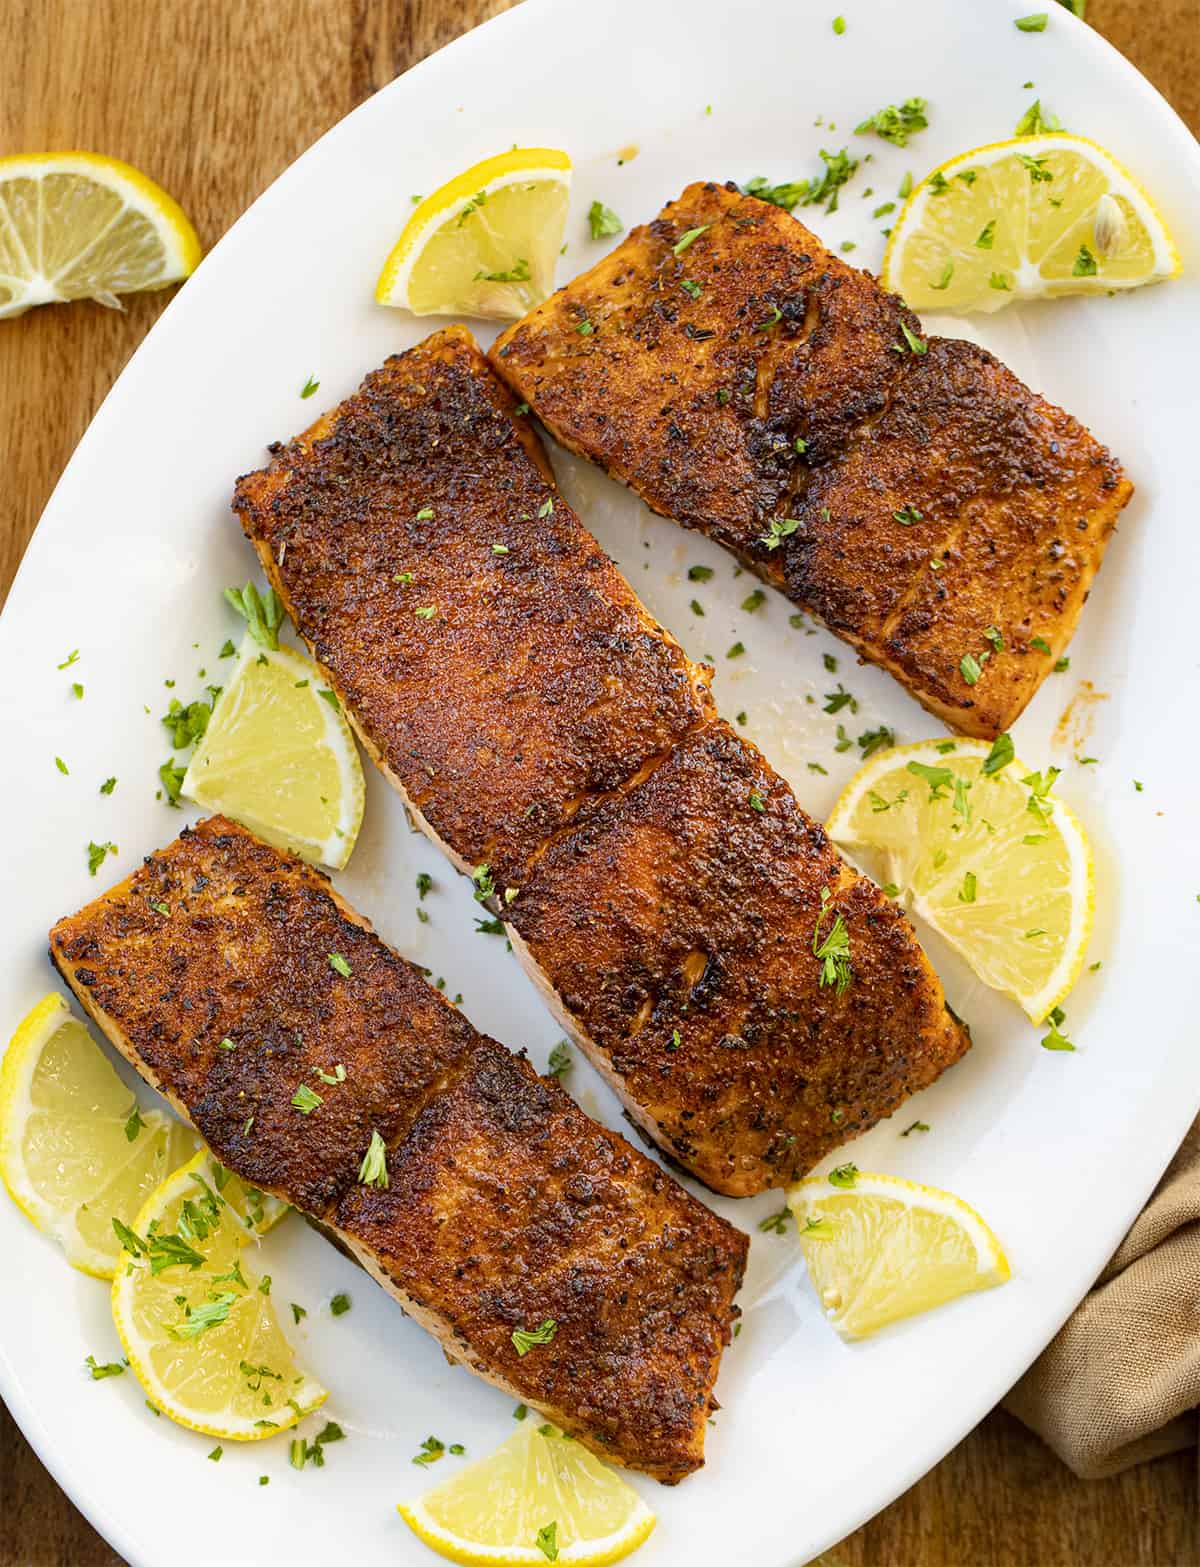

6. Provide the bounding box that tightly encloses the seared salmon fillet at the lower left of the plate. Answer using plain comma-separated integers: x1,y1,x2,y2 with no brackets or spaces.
50,816,747,1484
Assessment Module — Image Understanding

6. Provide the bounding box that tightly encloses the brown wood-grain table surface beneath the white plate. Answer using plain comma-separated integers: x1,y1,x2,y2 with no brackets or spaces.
0,0,1200,1567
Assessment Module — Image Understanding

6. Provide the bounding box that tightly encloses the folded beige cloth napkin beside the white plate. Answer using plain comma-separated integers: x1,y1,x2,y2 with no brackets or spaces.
1004,1120,1200,1479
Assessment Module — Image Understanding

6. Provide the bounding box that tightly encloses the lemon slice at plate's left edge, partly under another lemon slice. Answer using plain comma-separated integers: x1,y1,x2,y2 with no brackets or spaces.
0,995,199,1279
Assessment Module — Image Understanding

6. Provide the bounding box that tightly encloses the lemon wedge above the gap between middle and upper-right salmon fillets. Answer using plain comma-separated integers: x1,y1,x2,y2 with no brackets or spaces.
374,147,570,321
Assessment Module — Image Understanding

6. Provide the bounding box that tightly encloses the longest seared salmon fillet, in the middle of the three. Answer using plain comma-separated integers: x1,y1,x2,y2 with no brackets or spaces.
233,329,968,1196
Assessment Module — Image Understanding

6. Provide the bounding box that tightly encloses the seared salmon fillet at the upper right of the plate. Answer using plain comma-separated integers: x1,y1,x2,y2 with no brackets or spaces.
490,183,1133,738
